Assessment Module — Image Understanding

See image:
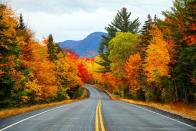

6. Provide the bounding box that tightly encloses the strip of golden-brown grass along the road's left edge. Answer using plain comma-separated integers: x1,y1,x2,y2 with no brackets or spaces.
0,89,88,119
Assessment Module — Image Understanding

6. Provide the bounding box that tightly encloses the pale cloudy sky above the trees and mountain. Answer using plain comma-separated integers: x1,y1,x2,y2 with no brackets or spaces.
4,0,172,41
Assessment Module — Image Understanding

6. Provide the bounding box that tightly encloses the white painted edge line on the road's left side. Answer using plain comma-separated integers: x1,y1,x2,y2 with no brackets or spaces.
0,105,64,131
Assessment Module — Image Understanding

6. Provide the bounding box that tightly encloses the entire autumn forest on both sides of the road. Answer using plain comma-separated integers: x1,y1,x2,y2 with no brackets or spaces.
0,0,196,107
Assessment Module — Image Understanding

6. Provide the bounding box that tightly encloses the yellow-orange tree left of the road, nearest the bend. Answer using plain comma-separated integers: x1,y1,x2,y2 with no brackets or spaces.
56,53,83,100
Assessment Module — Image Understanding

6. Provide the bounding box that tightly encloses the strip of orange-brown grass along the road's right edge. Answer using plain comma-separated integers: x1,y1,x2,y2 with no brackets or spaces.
95,85,196,121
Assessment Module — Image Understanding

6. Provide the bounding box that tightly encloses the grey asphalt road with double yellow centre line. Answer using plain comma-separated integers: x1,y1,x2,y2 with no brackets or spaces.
0,85,196,131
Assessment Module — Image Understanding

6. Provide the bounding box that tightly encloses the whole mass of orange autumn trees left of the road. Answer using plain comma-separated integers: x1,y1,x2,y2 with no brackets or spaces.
0,4,87,107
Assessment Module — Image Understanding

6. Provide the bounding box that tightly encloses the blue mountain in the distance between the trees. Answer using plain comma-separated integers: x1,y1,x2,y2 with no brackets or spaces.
58,32,106,58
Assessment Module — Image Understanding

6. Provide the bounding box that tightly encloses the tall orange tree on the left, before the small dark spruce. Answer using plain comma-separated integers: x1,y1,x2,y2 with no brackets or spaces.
25,42,59,101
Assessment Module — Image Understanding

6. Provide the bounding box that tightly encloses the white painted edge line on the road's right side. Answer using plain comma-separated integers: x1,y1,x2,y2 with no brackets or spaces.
121,101,196,129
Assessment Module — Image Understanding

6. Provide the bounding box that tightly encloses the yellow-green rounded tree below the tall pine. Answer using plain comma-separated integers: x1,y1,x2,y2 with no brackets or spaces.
109,32,138,79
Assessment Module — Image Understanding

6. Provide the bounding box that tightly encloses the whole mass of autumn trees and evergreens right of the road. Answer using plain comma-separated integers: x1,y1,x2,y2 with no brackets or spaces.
89,0,196,102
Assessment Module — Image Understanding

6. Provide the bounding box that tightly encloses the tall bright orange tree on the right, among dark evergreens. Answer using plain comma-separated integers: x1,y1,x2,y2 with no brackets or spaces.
144,25,170,82
